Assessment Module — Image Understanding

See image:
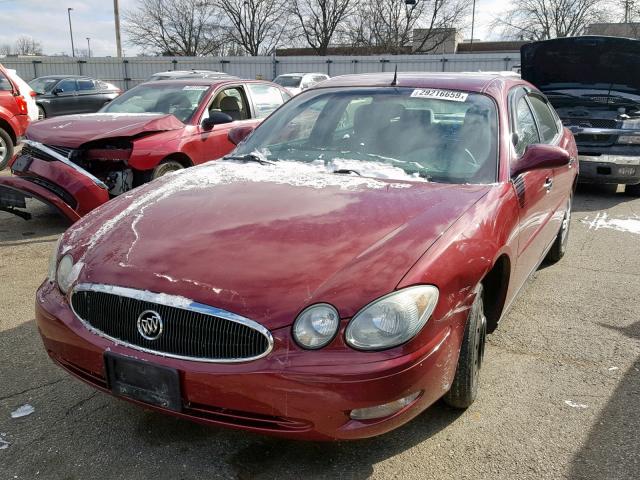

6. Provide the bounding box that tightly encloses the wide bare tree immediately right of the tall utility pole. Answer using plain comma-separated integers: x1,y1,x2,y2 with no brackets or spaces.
123,0,225,56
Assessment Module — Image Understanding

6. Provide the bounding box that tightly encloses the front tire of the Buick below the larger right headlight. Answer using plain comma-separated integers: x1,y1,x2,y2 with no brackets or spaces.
443,284,487,409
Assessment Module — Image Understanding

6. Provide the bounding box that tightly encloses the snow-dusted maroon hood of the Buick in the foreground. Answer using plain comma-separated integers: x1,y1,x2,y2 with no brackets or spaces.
61,161,491,328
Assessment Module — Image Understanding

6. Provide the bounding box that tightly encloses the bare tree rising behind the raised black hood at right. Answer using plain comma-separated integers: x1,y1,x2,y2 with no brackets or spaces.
493,0,608,40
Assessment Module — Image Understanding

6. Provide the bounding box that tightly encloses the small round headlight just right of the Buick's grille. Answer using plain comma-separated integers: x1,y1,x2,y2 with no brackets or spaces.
293,303,340,350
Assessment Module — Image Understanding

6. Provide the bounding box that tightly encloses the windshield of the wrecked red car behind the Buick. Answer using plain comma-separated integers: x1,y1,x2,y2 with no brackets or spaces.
101,82,209,123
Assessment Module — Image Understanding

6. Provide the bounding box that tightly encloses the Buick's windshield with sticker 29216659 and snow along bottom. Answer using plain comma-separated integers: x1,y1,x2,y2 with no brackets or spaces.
234,87,498,183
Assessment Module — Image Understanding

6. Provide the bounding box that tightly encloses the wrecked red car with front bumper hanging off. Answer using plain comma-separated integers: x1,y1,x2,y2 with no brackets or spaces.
0,78,291,222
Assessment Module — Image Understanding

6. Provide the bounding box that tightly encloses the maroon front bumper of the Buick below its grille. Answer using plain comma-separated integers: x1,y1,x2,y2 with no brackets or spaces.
36,282,461,440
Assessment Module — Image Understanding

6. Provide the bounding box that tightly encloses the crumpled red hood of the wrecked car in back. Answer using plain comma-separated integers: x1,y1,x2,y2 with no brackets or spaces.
27,113,184,148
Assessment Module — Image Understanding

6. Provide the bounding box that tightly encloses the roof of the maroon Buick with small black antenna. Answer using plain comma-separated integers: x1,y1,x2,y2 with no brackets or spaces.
314,72,526,92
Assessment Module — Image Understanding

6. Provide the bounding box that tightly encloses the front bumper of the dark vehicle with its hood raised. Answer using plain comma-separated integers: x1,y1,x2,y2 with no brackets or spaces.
578,154,640,185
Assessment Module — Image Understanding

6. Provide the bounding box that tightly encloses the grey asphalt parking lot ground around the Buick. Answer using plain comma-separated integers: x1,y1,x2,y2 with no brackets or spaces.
0,178,640,480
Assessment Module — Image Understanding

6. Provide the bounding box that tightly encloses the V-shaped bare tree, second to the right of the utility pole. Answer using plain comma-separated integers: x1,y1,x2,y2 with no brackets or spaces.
216,0,289,55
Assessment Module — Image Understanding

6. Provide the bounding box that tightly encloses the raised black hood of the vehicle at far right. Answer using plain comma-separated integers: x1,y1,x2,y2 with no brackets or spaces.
520,36,640,94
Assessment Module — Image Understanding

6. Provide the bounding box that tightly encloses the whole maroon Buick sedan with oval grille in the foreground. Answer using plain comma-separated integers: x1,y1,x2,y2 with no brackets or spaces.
36,73,578,439
